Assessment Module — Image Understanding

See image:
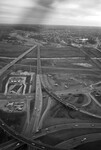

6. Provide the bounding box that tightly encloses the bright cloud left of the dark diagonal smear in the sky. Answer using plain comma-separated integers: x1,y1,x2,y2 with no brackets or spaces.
0,0,32,23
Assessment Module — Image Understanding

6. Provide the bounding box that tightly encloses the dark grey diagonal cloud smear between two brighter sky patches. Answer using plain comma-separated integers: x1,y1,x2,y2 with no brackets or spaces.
24,0,66,24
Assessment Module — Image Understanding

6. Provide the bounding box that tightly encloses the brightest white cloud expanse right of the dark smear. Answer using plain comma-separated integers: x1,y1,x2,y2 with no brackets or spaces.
46,0,101,26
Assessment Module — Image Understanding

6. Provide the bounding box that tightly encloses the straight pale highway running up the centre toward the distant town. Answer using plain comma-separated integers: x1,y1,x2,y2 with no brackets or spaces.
22,46,42,137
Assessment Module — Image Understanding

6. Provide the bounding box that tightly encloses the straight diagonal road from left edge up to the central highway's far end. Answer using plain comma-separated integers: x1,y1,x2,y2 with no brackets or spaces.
0,45,37,76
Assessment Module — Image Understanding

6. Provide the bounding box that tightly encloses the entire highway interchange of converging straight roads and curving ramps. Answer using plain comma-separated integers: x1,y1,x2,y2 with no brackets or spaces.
0,45,101,150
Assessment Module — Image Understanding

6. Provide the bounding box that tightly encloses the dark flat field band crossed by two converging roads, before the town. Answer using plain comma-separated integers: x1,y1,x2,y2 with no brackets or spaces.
0,43,85,58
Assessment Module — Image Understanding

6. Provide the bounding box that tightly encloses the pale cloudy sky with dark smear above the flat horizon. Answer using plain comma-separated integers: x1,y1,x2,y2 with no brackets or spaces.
0,0,101,26
